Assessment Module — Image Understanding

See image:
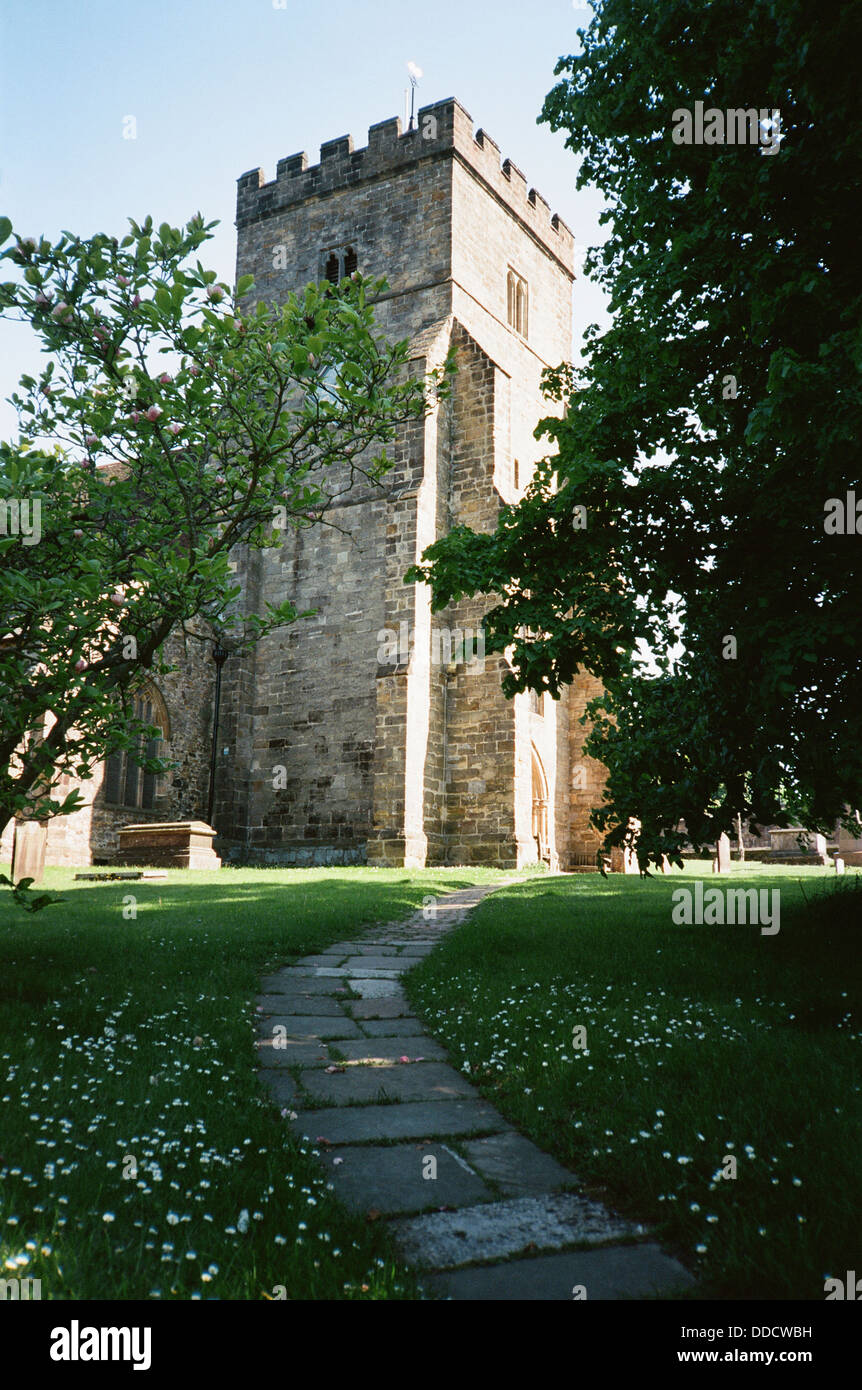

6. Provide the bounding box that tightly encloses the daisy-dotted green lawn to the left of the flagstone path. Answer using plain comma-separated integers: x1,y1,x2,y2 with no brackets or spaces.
0,869,501,1300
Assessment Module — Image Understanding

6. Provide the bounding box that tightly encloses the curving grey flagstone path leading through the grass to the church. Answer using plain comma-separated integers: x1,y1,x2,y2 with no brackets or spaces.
257,880,694,1300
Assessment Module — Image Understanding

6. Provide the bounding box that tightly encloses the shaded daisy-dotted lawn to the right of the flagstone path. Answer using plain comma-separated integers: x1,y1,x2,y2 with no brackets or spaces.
406,863,862,1300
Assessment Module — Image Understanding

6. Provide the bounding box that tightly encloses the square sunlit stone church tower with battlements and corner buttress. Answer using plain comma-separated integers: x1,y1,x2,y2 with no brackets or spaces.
214,99,601,867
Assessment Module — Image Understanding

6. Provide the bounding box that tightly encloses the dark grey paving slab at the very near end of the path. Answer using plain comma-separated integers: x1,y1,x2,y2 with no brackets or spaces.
423,1244,695,1302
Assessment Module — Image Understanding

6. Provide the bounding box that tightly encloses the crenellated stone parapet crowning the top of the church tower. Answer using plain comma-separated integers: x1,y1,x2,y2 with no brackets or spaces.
236,97,574,279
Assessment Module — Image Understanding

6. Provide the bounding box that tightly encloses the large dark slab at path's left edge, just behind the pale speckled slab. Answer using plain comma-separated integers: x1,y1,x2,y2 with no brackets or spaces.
323,1144,494,1216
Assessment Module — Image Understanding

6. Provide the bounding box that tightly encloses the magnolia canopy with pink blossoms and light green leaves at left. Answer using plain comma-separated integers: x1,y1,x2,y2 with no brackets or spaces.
0,215,446,872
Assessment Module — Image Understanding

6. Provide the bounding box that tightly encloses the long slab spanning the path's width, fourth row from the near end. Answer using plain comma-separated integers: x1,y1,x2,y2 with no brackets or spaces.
291,1101,510,1144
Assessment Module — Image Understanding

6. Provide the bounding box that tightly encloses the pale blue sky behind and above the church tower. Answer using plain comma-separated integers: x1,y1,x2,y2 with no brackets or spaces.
0,0,605,438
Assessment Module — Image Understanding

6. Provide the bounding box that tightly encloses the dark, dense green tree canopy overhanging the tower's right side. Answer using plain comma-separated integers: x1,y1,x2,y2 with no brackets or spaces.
412,0,862,855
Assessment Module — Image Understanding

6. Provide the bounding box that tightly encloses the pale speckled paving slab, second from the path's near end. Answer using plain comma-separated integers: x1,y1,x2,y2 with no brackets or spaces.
392,1193,642,1269
